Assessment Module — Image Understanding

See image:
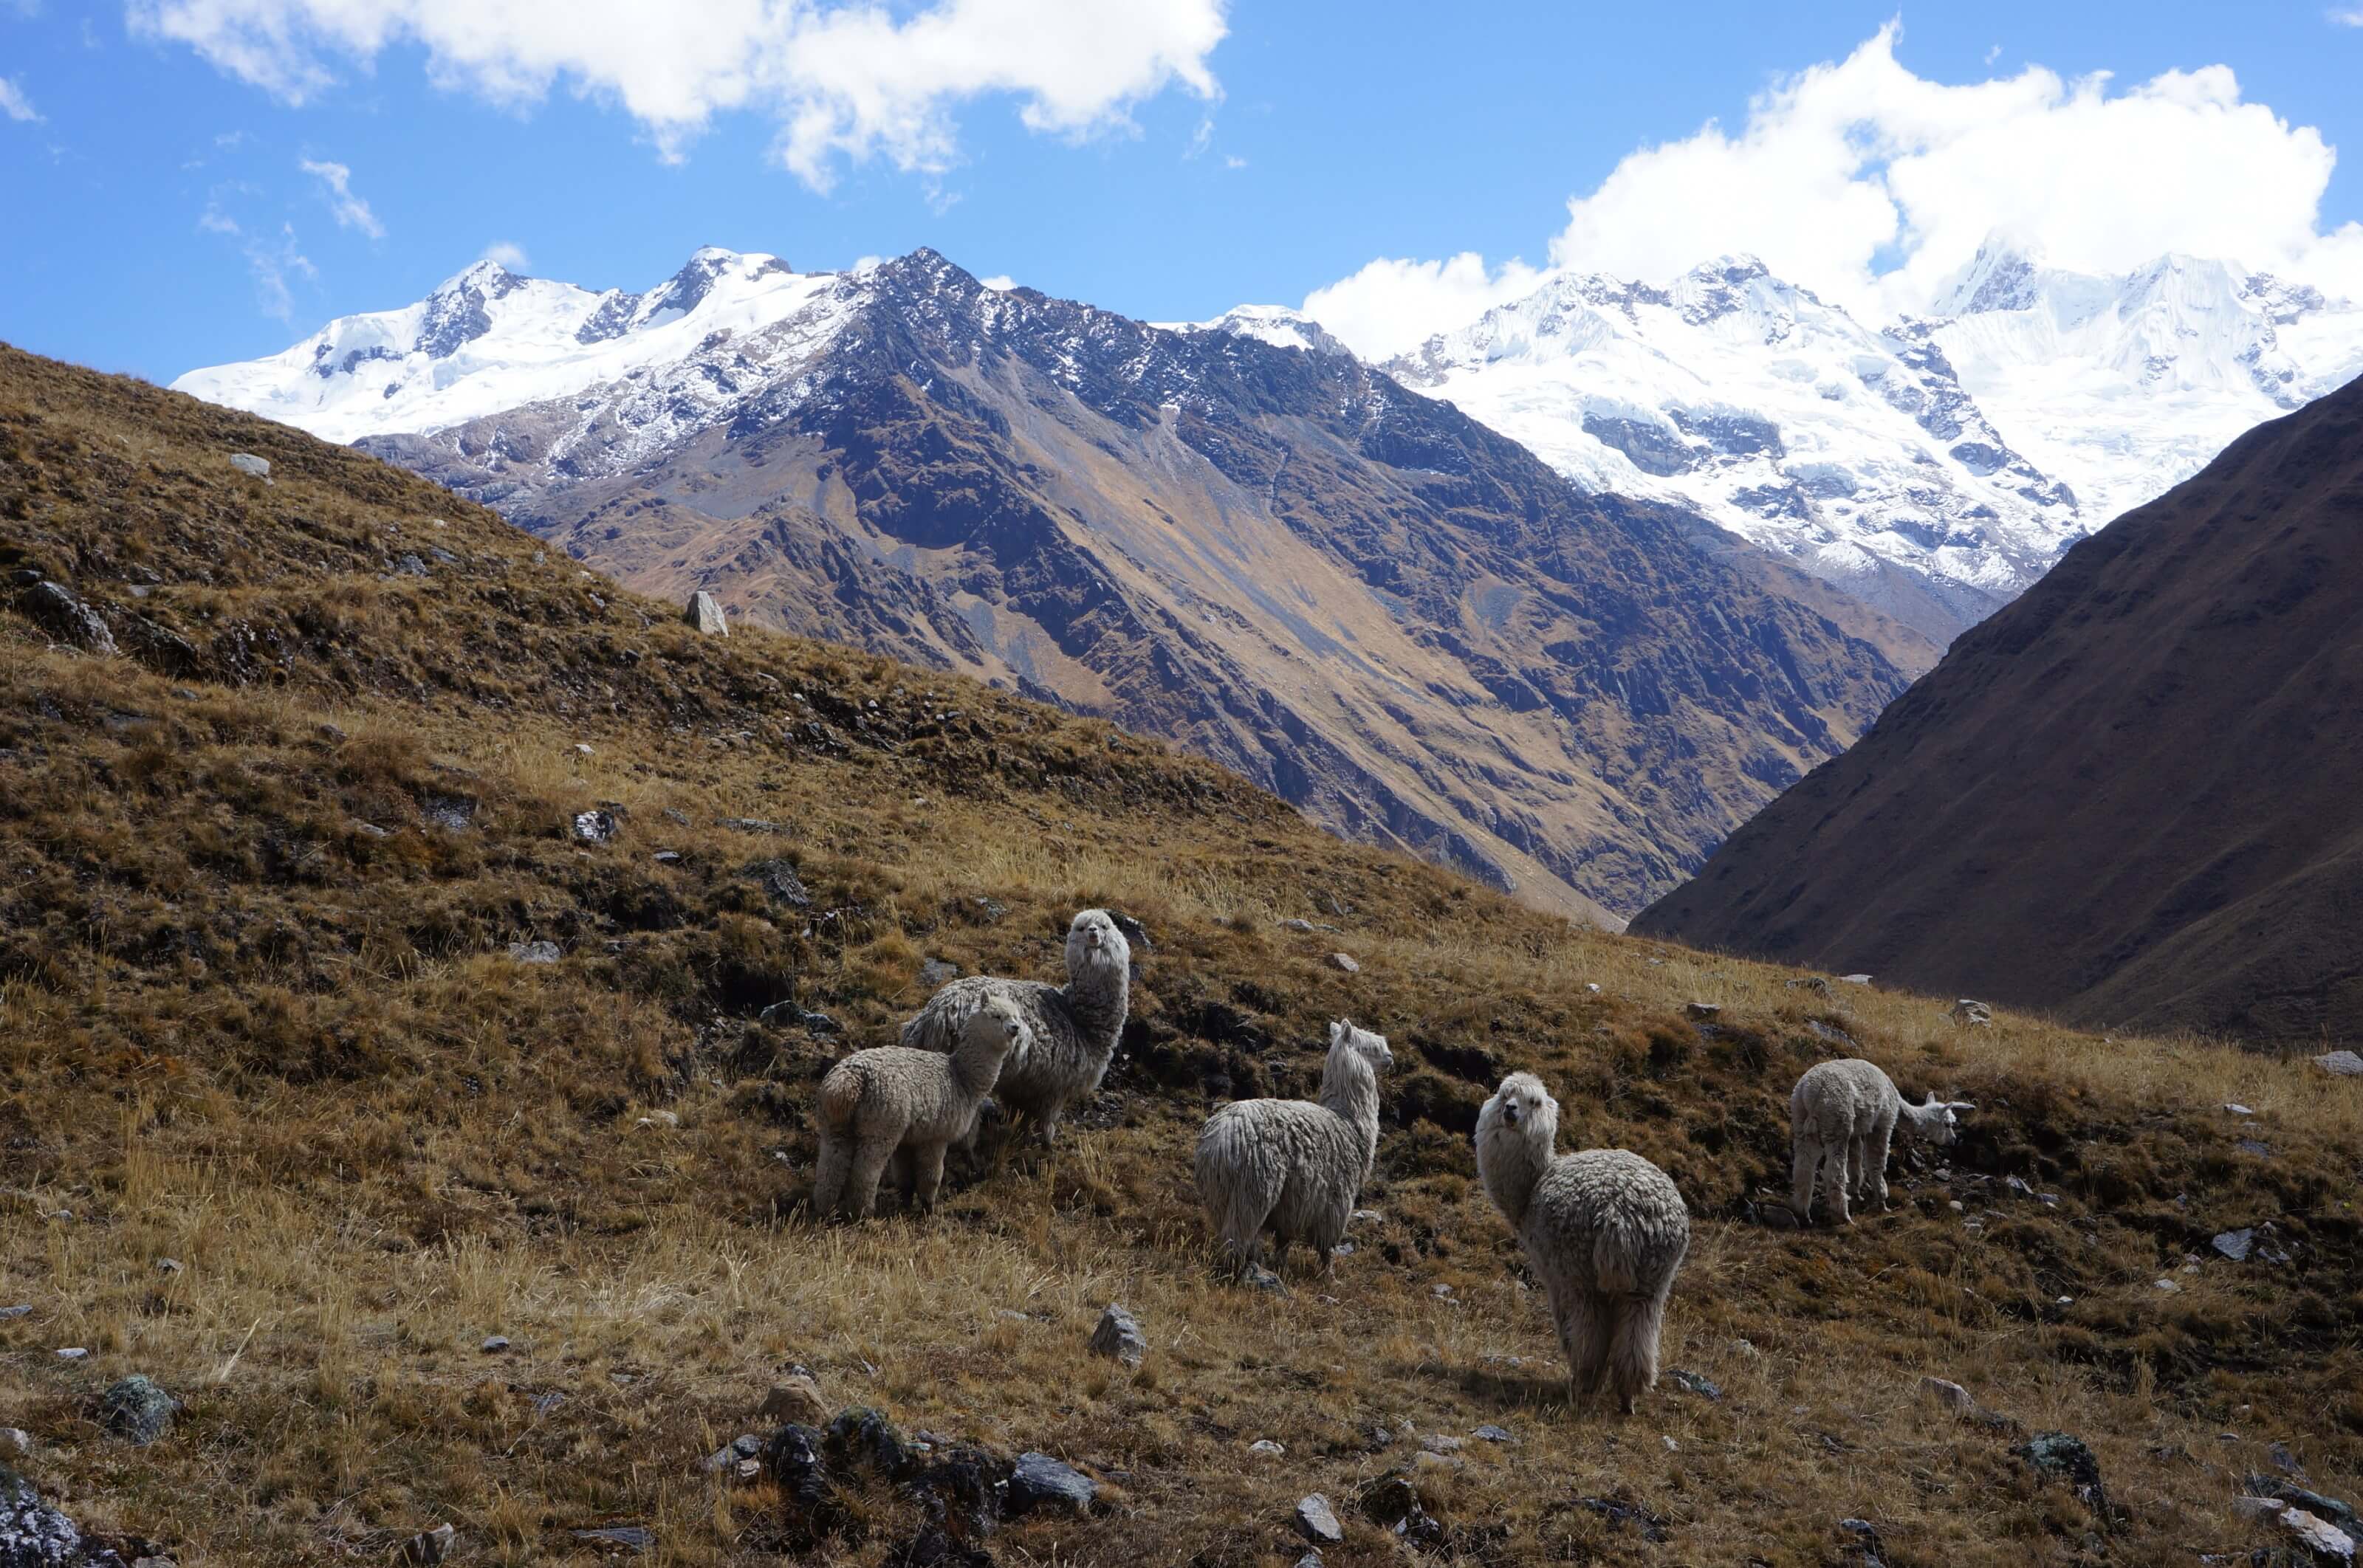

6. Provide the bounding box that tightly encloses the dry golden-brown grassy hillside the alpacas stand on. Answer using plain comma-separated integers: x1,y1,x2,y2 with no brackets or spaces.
0,352,2363,1568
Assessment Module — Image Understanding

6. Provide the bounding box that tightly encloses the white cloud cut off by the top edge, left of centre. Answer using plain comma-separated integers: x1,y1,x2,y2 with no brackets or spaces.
128,0,1227,189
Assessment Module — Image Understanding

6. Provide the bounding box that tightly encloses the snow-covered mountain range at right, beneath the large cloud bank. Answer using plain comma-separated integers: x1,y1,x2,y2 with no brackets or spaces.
1351,243,2363,644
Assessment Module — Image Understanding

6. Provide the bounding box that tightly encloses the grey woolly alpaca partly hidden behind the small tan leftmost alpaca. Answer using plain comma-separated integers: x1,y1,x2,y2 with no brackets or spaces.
902,909,1132,1145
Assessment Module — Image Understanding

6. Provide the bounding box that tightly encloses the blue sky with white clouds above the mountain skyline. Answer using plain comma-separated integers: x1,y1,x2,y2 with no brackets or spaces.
0,0,2363,380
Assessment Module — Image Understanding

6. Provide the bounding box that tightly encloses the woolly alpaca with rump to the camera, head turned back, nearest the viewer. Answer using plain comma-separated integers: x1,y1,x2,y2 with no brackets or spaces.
1477,1072,1690,1414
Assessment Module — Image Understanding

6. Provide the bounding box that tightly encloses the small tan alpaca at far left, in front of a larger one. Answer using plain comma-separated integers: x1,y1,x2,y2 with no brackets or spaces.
813,997,1026,1219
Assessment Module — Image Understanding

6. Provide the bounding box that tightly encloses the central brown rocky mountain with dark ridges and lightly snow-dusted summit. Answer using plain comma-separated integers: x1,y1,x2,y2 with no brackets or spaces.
364,250,1926,924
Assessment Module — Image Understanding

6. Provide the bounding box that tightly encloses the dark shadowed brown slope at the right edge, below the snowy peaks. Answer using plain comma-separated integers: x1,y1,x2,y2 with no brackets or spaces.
1635,371,2363,1039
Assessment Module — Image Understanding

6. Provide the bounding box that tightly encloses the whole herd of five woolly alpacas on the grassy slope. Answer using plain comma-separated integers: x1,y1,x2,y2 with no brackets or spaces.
813,909,1975,1414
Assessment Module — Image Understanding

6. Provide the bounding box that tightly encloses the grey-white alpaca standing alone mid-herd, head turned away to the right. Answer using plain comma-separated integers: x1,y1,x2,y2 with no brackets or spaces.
1196,1020,1394,1273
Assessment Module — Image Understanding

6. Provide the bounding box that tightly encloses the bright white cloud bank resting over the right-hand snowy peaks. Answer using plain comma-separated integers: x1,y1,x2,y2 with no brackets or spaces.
1304,24,2363,352
